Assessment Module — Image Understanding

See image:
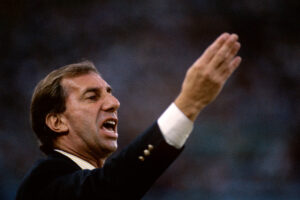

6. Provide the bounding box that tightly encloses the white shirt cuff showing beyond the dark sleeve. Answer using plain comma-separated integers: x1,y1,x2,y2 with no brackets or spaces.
157,103,194,149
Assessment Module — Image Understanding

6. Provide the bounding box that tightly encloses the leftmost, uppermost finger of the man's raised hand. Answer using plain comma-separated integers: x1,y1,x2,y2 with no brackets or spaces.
195,33,230,65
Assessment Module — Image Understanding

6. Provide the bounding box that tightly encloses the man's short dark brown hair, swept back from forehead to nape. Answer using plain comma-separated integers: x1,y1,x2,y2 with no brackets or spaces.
30,61,99,154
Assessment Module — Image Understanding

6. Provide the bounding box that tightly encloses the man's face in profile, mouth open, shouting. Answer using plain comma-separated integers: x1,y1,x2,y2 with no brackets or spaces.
61,72,120,157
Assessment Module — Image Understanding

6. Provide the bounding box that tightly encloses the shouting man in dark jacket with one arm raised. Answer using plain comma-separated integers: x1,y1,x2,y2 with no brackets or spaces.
17,33,241,200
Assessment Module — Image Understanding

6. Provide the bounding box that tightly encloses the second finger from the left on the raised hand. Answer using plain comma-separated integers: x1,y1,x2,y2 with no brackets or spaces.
210,34,238,68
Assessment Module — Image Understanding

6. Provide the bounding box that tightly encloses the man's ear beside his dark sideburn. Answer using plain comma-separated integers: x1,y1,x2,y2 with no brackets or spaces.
45,113,69,133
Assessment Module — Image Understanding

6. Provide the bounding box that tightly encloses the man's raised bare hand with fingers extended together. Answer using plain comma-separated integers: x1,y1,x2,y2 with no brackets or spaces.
175,33,241,121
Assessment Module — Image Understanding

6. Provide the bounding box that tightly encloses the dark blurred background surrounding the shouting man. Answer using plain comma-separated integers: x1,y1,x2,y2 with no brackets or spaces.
0,0,300,200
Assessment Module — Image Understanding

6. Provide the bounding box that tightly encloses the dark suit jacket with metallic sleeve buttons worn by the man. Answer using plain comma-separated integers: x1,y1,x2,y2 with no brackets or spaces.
17,123,182,200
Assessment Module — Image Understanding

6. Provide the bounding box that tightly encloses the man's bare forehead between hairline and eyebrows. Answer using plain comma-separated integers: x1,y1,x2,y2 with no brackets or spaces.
61,72,108,93
